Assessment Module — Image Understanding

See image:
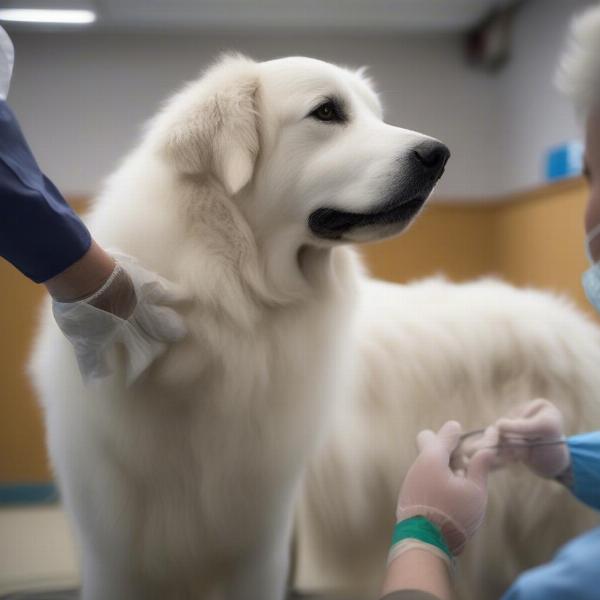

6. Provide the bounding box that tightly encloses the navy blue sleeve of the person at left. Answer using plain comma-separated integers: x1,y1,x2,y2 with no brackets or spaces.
0,100,92,283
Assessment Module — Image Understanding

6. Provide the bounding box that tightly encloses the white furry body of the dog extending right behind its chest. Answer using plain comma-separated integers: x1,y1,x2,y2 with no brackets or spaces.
296,279,600,600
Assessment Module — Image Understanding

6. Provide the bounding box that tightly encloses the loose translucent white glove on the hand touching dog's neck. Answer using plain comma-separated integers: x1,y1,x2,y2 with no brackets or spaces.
52,255,187,385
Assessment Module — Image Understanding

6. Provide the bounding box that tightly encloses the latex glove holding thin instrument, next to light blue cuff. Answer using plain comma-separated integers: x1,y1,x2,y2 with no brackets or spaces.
496,398,571,478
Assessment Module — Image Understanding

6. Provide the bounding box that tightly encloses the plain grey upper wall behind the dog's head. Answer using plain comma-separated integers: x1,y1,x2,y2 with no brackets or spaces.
9,0,593,199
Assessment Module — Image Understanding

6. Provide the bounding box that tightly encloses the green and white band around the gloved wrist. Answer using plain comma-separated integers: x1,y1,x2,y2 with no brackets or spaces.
388,516,454,573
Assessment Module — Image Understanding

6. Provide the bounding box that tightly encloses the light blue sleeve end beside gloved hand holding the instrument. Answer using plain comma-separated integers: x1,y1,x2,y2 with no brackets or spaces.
567,431,600,510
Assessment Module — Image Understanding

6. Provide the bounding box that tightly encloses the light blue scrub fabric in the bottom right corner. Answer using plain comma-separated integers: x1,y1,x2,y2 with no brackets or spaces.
502,528,600,600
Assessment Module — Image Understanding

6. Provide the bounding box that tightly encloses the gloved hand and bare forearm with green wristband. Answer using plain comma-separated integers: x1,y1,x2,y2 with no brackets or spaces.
382,421,497,600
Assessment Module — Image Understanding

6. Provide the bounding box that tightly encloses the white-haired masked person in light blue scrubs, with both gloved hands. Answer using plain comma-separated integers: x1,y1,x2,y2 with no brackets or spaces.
383,6,600,600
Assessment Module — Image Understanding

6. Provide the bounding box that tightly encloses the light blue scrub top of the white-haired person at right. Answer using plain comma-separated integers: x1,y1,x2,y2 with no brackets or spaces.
502,431,600,600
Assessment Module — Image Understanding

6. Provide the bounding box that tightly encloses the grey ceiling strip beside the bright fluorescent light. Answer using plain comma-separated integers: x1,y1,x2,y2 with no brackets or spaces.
2,0,511,33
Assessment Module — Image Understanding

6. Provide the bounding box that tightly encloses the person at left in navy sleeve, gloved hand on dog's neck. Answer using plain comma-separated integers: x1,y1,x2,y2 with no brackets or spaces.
0,27,186,384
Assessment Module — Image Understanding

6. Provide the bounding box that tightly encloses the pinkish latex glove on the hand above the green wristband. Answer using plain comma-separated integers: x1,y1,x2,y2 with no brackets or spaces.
396,421,497,555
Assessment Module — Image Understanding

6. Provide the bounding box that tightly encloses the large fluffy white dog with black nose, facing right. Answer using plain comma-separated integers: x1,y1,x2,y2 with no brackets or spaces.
31,56,600,600
